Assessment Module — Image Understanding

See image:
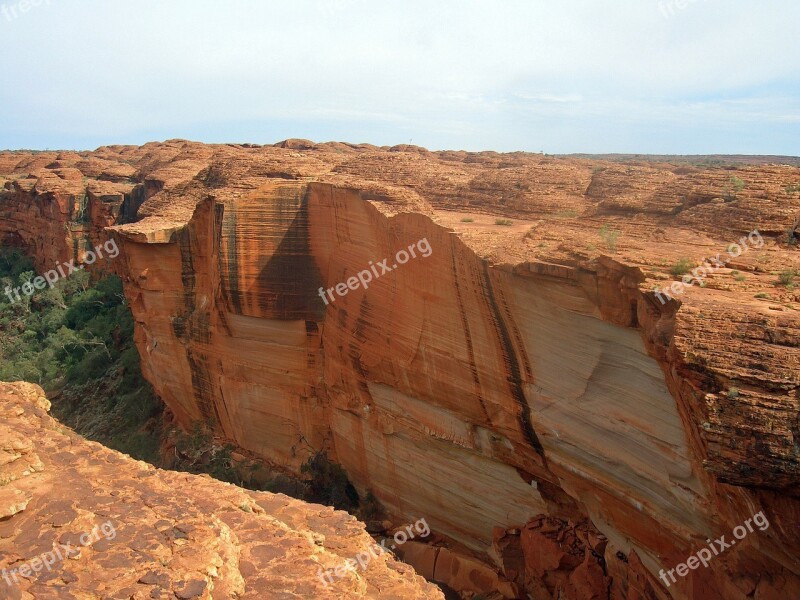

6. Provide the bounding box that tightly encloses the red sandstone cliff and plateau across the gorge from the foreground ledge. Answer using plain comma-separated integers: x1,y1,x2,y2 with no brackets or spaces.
0,141,800,599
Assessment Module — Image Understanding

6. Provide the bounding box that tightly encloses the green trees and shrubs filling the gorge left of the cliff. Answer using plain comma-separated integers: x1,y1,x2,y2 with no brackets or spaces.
0,248,162,463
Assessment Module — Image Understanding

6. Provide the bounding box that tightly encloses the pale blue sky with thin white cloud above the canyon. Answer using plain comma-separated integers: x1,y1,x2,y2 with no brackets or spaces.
0,0,800,156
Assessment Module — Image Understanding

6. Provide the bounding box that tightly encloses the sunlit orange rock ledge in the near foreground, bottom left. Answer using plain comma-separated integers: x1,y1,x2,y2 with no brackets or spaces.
0,383,443,600
